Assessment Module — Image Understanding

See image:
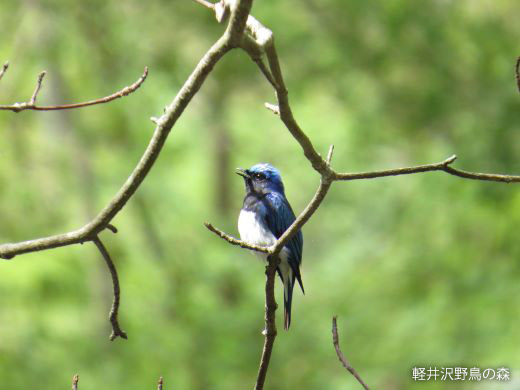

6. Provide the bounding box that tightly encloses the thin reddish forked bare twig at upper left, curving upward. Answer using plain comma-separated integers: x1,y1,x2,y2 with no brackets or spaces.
0,67,148,112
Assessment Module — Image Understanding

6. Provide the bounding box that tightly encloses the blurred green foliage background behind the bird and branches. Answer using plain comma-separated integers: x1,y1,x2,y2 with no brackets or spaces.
0,0,520,390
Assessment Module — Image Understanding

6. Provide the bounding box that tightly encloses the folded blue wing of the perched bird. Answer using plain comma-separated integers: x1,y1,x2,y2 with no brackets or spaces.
263,193,303,291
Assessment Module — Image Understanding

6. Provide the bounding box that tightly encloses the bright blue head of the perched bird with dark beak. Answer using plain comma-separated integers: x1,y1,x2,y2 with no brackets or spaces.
236,163,284,194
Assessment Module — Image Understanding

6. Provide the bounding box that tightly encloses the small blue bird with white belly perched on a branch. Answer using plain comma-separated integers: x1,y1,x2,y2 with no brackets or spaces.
236,163,305,330
